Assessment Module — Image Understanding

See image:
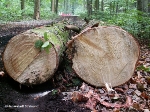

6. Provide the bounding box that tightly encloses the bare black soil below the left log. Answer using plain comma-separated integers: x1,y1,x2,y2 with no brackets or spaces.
0,76,90,112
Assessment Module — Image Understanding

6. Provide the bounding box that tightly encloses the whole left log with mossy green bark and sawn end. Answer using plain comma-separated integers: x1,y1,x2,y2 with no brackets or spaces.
3,23,68,85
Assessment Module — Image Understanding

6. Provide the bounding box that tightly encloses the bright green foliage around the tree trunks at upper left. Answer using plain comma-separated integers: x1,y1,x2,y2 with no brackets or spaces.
0,0,57,22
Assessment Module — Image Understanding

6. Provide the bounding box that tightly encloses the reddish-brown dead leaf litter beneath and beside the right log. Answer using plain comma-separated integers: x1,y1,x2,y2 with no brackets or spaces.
57,47,150,112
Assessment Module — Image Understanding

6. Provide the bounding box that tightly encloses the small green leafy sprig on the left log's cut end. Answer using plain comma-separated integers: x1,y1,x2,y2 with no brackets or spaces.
35,32,52,53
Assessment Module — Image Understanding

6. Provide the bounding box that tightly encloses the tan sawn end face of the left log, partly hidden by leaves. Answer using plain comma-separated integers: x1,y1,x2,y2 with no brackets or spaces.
3,32,58,84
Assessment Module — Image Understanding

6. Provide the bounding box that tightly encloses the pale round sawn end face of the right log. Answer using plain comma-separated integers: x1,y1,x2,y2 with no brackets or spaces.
72,26,140,87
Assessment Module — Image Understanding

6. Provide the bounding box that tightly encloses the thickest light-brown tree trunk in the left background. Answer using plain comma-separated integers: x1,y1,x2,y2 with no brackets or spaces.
33,0,40,20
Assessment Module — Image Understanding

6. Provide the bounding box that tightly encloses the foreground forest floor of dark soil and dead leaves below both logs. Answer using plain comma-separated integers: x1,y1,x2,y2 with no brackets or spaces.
0,18,150,112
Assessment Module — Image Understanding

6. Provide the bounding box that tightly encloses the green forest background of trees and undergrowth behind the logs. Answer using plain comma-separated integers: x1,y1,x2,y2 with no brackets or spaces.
0,0,150,42
